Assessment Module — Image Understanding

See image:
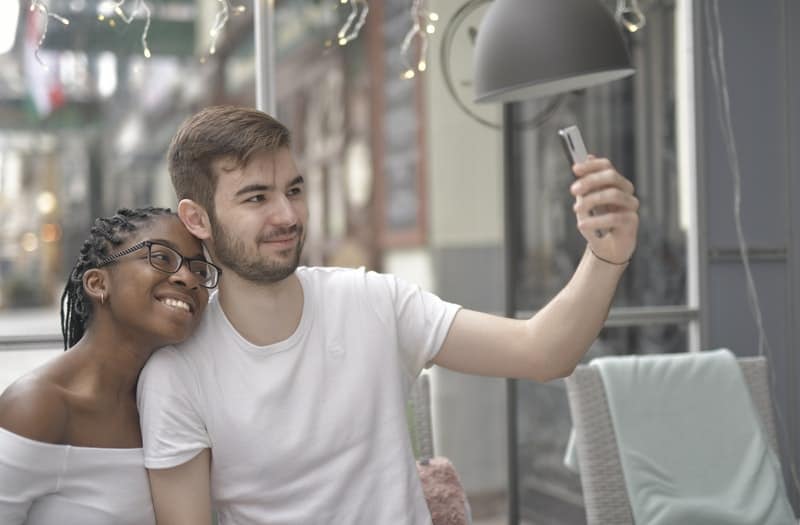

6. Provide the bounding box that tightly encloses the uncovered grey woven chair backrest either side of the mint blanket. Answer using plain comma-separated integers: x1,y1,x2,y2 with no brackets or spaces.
565,357,778,525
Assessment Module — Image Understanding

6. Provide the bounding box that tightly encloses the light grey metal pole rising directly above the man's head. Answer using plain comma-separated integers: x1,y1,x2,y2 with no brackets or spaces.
253,0,275,116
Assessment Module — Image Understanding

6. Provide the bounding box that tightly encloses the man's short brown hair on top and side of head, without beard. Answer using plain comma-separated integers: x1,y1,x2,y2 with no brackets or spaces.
167,106,291,217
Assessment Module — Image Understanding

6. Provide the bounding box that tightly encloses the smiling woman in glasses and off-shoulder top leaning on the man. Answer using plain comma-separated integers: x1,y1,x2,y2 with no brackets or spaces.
0,208,220,525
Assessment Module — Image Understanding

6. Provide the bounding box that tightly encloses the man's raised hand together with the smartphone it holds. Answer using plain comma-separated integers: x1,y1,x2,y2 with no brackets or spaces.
559,126,639,264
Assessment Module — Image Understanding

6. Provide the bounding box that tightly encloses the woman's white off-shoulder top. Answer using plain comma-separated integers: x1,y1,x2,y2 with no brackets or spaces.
0,428,156,525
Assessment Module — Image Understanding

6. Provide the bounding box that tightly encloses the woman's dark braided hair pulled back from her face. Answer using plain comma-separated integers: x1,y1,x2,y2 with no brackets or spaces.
61,207,175,350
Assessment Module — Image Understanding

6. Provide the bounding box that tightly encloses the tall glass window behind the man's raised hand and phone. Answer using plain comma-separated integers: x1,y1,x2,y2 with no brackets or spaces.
511,1,698,523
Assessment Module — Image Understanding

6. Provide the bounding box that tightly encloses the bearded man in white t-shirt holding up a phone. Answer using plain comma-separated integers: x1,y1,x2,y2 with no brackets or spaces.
138,107,638,525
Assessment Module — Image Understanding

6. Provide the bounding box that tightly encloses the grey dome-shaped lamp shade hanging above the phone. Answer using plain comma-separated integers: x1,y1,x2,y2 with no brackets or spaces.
474,0,634,102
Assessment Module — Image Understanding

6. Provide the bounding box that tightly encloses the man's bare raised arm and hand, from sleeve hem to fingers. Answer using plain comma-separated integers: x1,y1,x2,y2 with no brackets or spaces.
433,157,639,381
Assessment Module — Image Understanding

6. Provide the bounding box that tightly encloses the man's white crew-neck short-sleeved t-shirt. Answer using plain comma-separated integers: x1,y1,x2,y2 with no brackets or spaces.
138,267,459,525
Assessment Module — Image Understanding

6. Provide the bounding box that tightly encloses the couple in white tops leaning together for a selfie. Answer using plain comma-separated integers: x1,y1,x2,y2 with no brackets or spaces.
0,107,638,525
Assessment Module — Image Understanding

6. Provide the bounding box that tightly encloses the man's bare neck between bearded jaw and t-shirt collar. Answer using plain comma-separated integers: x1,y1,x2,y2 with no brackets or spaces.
219,273,304,346
